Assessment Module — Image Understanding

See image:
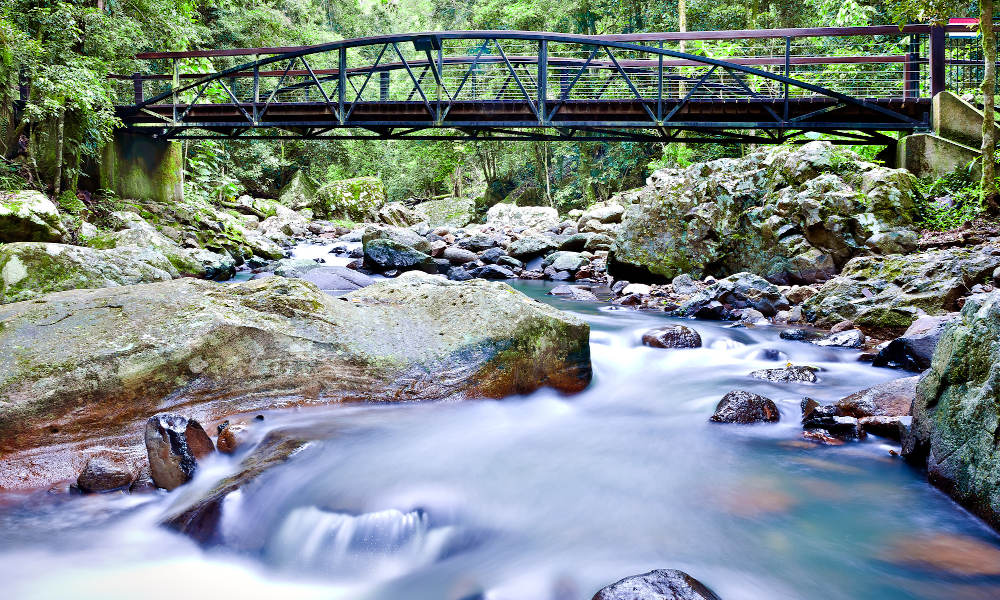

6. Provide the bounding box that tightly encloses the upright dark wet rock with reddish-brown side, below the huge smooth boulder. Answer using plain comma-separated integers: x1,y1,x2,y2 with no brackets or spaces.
145,413,215,490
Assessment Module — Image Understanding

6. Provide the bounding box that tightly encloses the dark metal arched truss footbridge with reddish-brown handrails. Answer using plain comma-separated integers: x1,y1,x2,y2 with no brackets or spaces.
103,25,982,144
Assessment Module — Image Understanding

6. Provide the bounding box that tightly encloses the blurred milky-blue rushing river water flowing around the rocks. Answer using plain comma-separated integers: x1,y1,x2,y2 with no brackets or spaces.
0,270,1000,600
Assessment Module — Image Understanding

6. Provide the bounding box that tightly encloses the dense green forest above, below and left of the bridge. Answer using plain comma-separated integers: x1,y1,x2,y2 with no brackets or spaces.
0,0,976,216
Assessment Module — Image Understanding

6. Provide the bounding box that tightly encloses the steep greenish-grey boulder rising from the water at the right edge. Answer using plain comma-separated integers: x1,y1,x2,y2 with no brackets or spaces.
903,292,1000,529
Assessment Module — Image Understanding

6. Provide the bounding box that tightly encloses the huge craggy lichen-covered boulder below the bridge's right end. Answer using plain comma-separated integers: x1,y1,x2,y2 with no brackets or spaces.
604,142,918,283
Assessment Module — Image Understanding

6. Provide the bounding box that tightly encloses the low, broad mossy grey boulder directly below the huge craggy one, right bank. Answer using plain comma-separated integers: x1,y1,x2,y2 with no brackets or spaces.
802,244,1000,333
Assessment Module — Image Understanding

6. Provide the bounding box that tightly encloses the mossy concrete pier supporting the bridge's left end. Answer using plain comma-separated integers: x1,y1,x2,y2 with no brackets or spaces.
100,130,184,202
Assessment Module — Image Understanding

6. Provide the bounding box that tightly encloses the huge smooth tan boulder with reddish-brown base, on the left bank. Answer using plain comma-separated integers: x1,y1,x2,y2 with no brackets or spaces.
0,273,591,487
